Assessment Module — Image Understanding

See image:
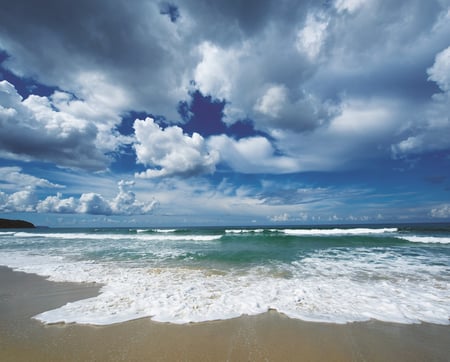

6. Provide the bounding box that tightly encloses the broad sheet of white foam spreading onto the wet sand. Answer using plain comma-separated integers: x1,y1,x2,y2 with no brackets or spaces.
0,249,450,325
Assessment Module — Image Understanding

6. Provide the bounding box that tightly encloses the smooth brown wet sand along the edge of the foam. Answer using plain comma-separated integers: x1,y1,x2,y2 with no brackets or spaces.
0,267,450,361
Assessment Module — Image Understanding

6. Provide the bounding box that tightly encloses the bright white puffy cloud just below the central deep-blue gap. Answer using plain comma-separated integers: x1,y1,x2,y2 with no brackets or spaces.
134,118,218,178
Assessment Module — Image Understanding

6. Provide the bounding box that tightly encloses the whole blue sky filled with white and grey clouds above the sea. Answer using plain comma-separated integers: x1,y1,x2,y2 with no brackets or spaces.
0,0,450,227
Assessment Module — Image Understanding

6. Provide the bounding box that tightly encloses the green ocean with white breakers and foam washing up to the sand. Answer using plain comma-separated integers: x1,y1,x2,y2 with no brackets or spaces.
0,224,450,325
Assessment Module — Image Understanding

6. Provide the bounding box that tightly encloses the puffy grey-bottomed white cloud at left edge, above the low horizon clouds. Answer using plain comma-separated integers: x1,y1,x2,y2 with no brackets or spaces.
0,81,116,170
